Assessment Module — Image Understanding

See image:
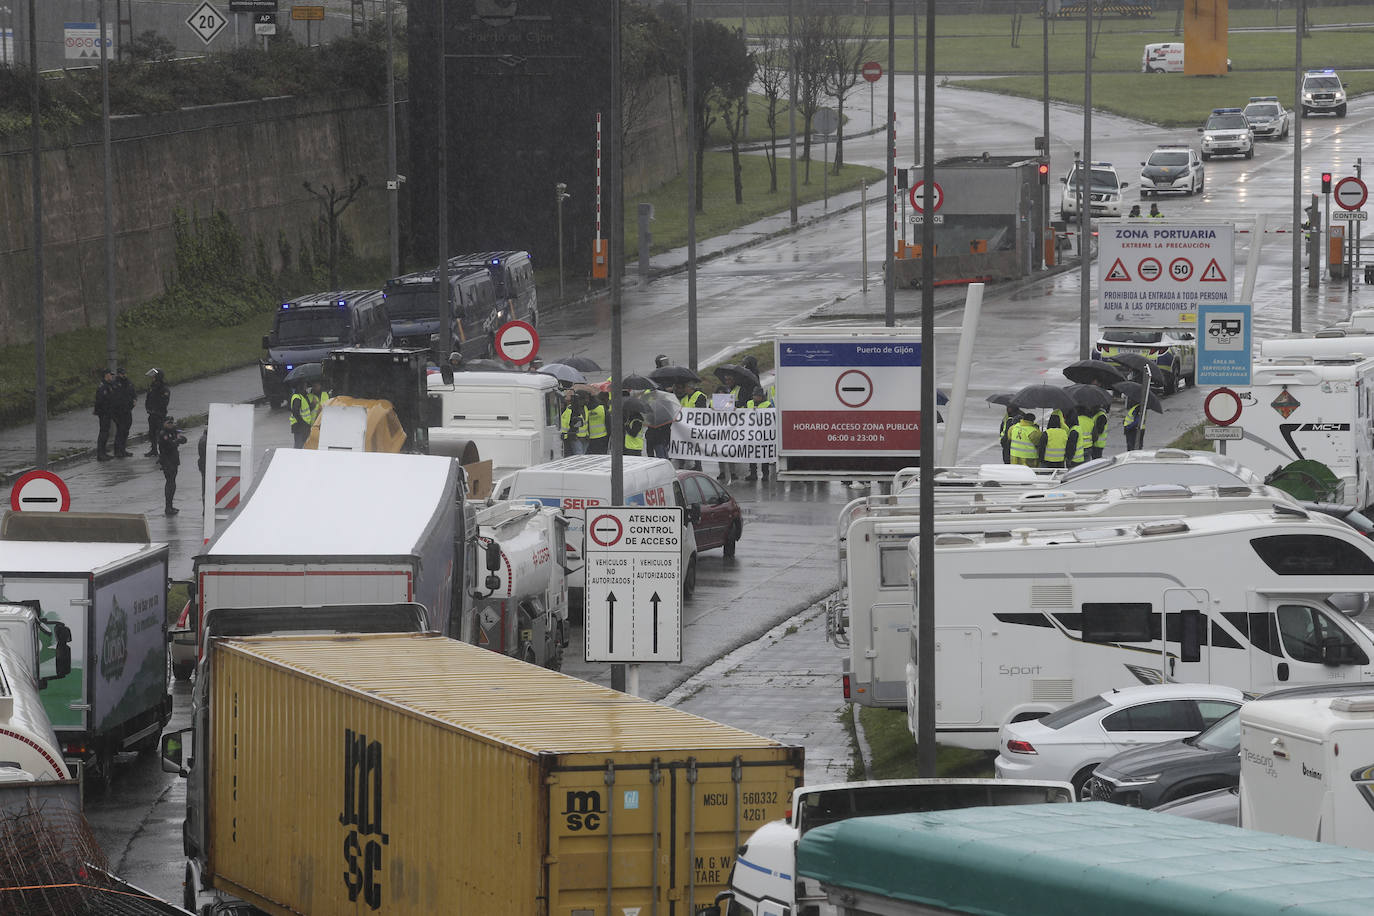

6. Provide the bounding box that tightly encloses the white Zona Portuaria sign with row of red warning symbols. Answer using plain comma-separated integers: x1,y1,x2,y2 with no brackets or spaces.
1098,220,1235,328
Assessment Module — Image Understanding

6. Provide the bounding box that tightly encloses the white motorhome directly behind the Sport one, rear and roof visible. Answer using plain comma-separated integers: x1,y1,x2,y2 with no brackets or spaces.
826,483,1296,709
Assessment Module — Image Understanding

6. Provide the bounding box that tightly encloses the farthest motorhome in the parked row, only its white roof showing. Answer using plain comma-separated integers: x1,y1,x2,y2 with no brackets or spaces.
892,448,1264,501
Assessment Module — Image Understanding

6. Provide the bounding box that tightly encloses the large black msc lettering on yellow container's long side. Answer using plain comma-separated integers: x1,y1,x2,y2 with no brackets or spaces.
339,728,390,909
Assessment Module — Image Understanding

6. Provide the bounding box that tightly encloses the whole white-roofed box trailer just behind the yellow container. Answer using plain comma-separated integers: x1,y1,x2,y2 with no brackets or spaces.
194,449,471,637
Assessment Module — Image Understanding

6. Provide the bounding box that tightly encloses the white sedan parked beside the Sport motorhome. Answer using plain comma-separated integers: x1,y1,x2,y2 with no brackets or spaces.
993,684,1245,794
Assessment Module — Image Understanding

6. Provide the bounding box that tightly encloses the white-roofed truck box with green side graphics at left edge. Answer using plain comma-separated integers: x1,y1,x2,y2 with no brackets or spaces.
0,540,172,781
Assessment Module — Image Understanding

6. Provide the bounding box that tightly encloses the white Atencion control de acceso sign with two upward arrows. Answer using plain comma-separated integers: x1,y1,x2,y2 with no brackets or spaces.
583,505,683,663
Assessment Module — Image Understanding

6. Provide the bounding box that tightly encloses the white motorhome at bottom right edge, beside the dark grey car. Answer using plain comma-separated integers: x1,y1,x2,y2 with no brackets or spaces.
1241,686,1374,850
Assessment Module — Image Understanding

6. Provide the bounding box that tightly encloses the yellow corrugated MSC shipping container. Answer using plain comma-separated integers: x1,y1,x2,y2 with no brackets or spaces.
207,634,802,916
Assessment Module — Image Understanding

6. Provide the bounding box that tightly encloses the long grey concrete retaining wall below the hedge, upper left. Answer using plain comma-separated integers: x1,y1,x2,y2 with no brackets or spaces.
0,96,405,343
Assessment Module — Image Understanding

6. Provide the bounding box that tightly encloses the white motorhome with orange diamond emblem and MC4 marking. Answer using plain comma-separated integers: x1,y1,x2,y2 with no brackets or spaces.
1226,347,1374,508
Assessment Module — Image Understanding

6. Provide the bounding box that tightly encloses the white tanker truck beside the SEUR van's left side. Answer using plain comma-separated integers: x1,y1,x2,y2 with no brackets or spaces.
462,501,569,672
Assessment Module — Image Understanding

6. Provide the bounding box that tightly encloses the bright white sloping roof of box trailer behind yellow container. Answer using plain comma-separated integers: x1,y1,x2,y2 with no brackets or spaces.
205,449,458,556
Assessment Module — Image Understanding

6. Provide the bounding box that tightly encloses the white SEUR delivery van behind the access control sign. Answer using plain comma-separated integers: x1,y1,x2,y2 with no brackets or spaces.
493,455,697,606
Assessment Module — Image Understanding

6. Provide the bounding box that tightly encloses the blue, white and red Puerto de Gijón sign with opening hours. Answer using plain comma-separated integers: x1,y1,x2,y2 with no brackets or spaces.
776,334,922,456
